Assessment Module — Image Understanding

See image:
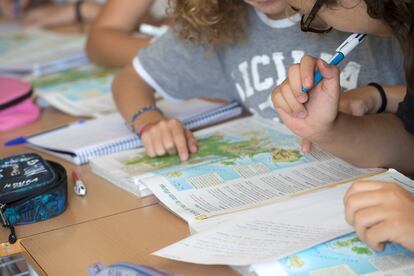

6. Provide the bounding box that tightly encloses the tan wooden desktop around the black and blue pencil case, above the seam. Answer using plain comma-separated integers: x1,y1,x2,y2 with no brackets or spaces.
0,108,157,255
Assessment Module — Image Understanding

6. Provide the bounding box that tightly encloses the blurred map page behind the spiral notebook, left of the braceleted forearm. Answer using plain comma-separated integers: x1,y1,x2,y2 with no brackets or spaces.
32,65,116,116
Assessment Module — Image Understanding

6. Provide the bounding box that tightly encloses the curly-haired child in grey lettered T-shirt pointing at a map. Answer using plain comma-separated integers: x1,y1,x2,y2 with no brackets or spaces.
113,0,403,163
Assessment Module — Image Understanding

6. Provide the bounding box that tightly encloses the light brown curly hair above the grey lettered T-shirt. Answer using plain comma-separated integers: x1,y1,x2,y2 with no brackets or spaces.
169,0,247,46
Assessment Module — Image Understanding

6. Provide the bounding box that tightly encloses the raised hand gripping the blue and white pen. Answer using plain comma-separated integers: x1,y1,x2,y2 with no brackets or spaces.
272,56,340,142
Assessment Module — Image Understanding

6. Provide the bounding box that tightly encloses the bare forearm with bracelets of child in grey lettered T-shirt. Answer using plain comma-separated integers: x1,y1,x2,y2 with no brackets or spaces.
112,65,164,129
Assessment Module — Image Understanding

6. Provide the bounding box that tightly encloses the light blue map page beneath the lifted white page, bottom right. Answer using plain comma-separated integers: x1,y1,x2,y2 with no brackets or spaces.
254,233,414,276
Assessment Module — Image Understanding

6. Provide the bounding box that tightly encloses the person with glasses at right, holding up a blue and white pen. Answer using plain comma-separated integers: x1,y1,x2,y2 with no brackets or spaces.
273,0,414,251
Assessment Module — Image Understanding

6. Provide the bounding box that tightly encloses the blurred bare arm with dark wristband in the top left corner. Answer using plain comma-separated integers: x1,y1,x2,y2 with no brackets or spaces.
1,0,103,28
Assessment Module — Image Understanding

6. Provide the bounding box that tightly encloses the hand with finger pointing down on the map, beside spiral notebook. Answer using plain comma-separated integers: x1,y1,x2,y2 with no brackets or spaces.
141,119,197,161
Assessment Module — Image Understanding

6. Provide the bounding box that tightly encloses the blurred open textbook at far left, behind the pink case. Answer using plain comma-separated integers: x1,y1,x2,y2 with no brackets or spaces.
0,26,88,77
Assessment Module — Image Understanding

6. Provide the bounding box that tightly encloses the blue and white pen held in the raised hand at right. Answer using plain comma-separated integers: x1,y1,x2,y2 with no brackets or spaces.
302,33,367,93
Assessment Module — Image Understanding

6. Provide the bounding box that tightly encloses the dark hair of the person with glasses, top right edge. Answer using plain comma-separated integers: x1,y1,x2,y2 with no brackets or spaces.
324,0,414,93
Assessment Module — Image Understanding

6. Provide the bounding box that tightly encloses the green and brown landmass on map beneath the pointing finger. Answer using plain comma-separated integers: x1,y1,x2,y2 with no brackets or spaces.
125,133,302,170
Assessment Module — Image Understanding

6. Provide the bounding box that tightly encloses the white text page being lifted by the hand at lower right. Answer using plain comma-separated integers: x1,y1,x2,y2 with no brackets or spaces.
153,171,414,266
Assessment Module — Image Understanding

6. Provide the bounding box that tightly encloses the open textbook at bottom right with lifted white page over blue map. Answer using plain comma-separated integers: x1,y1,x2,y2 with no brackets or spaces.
154,170,414,276
